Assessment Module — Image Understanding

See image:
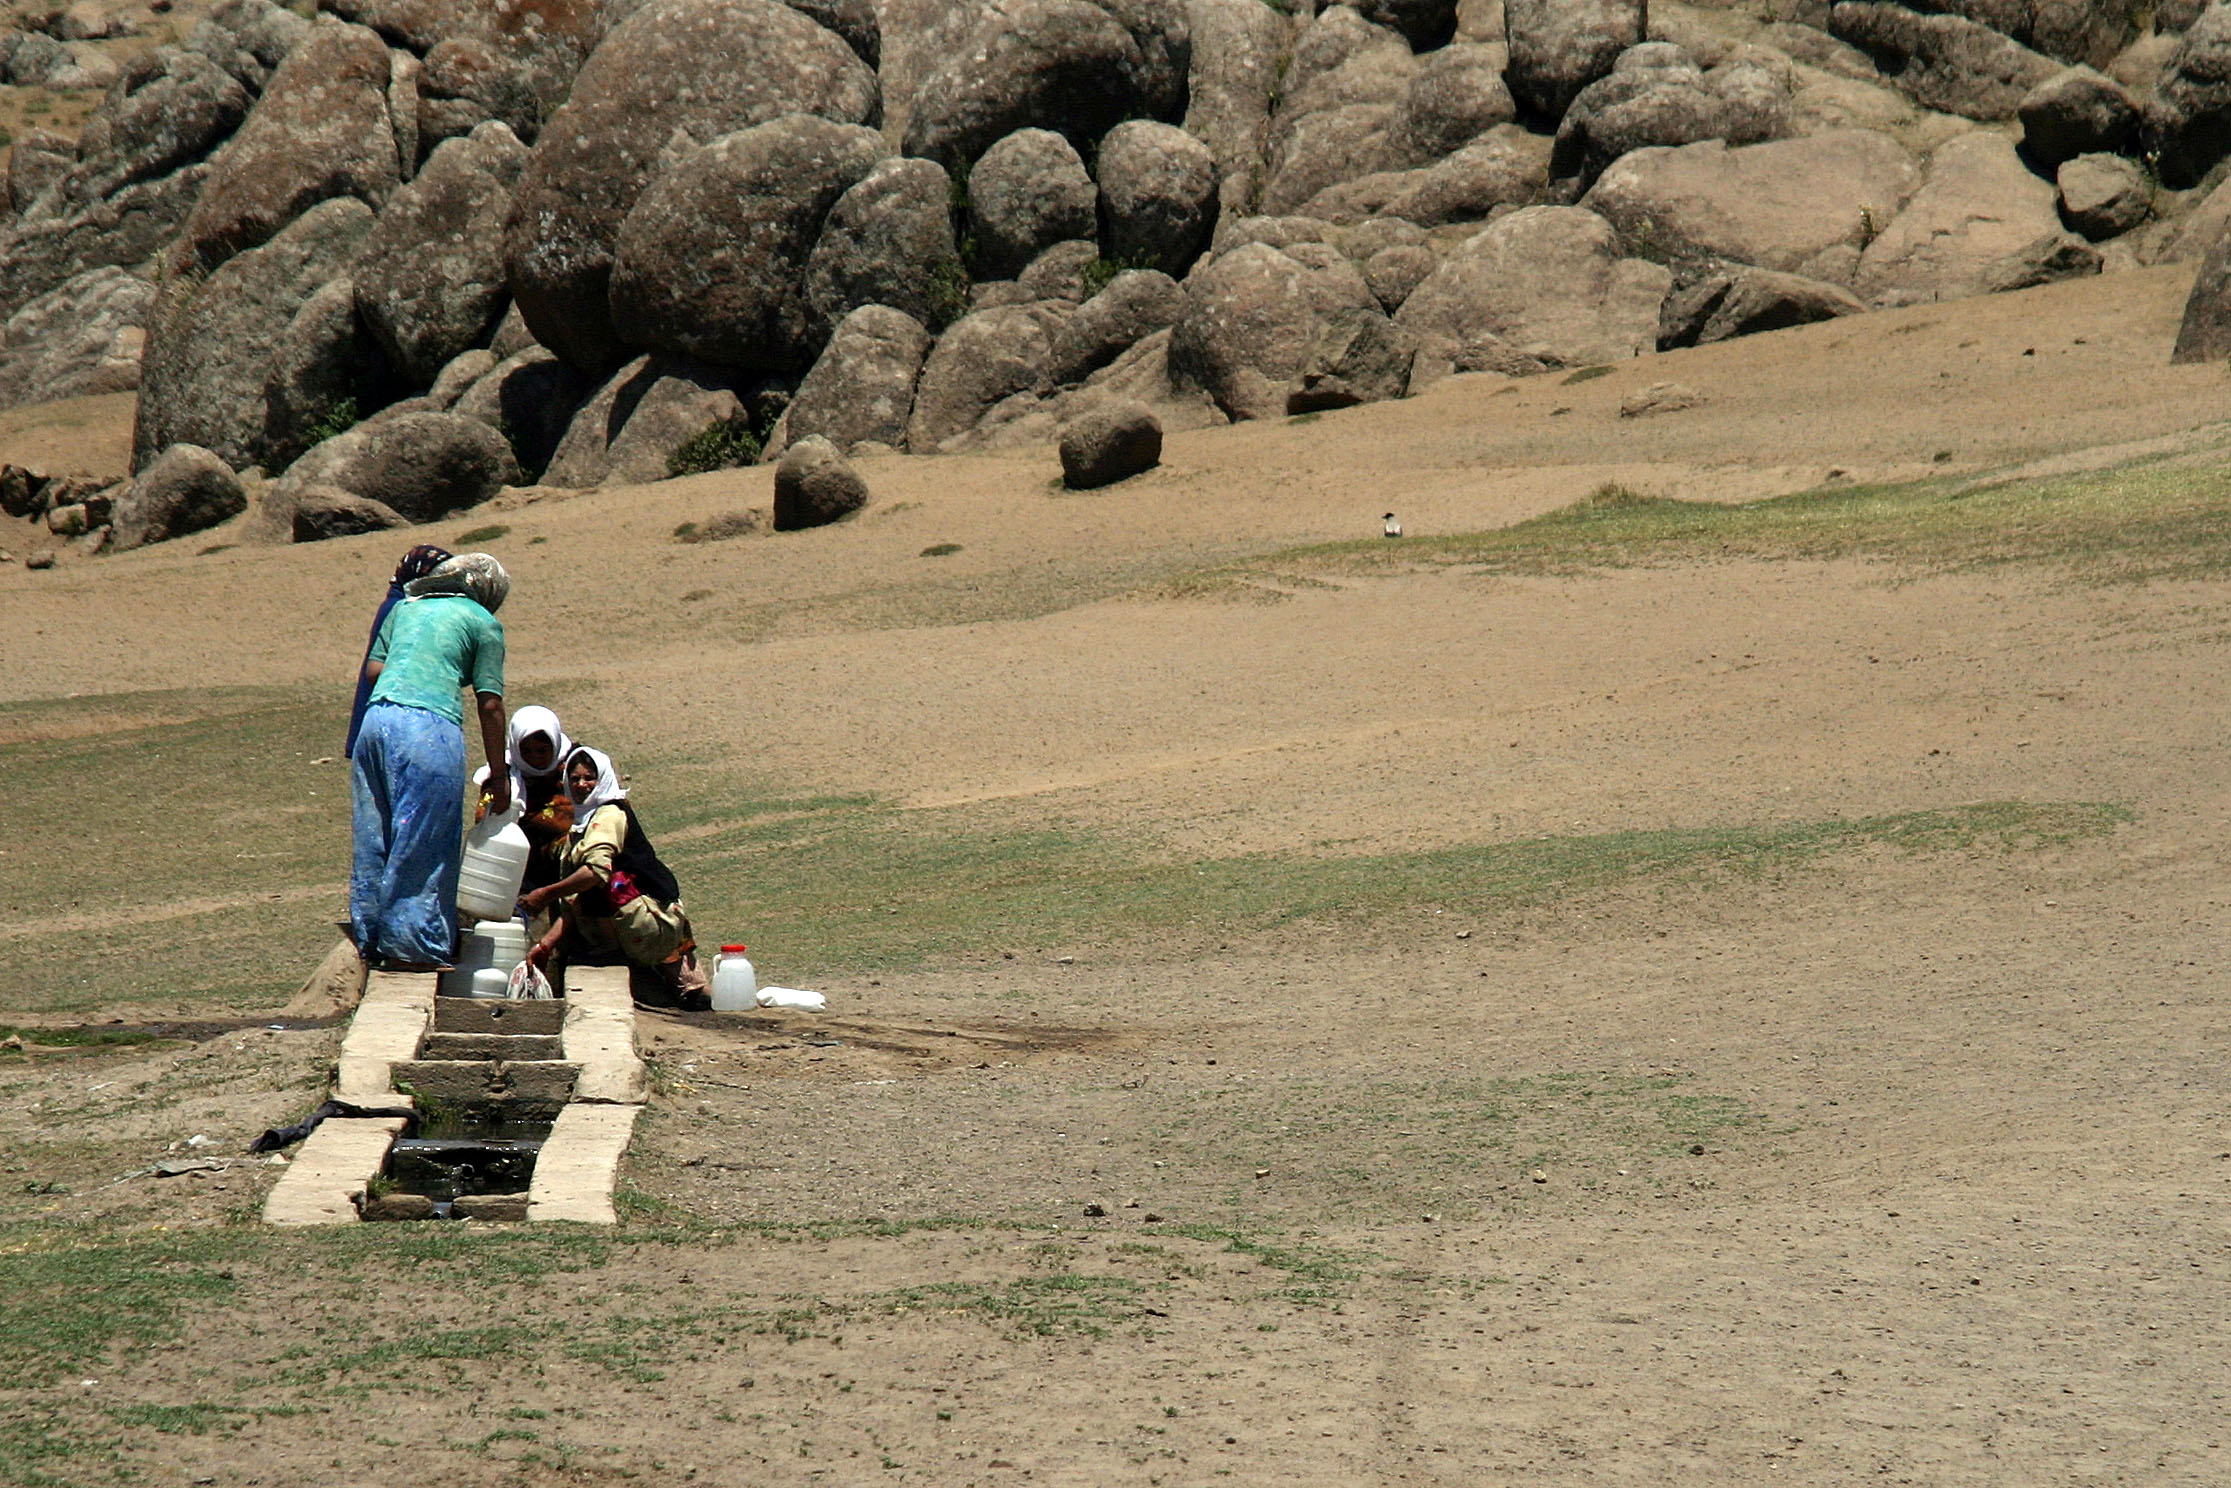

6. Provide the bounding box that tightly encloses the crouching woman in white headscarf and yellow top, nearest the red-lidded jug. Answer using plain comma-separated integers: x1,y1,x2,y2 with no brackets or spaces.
520,747,707,1008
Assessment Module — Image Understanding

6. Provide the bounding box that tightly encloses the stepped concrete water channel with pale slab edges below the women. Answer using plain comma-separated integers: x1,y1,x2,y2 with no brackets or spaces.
263,966,649,1225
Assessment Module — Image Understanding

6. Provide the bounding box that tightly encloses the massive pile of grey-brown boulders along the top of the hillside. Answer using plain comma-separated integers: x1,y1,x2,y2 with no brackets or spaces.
0,0,2231,547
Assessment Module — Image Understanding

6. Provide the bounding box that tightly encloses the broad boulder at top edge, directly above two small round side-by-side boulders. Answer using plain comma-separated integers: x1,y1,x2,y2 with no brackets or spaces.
906,0,1191,170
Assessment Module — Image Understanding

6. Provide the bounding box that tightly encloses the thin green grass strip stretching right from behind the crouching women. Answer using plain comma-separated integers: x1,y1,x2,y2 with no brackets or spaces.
647,801,2131,975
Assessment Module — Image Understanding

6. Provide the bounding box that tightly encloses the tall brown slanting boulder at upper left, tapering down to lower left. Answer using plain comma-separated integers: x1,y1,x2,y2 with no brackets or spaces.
170,20,404,272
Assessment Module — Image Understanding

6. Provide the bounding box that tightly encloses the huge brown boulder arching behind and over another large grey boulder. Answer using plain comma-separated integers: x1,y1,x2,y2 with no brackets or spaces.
504,0,879,375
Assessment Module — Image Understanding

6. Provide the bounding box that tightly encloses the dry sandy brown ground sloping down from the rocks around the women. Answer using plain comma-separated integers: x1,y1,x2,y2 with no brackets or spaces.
0,270,2231,1486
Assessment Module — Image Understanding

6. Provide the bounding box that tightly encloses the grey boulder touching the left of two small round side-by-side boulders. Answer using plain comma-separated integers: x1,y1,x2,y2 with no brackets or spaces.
805,158,968,346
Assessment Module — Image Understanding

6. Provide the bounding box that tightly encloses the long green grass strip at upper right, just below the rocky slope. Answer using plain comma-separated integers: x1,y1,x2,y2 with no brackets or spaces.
1225,464,2231,582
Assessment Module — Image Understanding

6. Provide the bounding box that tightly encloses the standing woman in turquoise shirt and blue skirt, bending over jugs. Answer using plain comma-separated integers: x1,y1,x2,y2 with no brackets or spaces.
348,553,511,970
